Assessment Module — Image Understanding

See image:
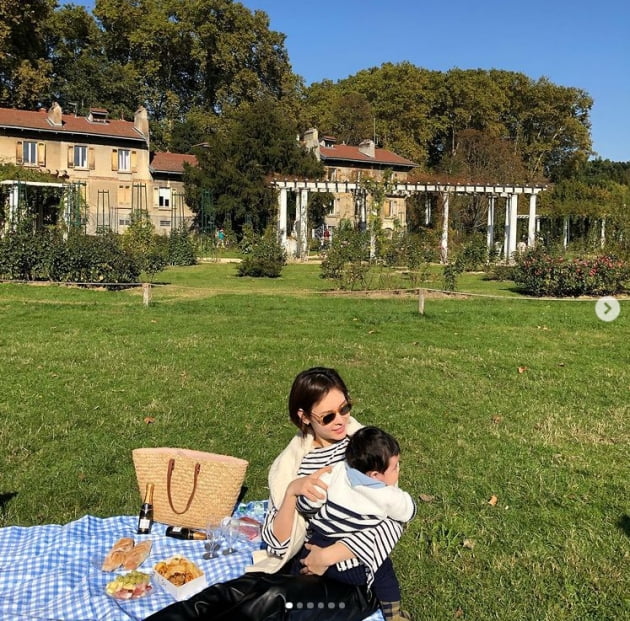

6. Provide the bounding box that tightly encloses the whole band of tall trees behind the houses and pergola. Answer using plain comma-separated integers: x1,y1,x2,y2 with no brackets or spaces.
0,0,630,235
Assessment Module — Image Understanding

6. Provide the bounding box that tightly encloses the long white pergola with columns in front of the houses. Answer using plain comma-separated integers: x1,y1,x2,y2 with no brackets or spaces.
272,179,546,263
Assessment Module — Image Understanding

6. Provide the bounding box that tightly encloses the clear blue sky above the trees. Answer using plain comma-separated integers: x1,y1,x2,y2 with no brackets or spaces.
69,0,630,162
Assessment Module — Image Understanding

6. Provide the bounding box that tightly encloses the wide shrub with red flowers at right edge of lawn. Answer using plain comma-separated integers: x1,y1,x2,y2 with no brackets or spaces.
514,248,630,297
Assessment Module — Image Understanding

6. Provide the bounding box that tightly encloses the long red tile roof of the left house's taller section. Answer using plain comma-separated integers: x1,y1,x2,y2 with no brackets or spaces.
0,108,145,141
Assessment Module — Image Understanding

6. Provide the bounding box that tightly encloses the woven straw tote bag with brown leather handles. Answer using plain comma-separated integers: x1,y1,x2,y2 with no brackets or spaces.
132,447,248,528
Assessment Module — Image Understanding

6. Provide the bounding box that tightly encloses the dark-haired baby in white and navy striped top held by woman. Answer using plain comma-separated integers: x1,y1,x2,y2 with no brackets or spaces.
297,427,416,621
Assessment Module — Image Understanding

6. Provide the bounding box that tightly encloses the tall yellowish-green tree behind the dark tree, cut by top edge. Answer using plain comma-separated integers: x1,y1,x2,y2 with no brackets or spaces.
90,0,297,146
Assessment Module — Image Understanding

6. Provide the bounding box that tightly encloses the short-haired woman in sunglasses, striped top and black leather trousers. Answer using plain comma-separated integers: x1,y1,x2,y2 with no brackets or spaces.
146,367,404,621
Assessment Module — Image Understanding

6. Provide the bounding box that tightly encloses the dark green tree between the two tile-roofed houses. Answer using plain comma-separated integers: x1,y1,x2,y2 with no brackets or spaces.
184,97,323,232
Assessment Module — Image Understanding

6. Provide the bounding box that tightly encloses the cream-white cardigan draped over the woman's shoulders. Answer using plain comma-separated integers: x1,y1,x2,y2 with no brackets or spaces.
245,417,363,574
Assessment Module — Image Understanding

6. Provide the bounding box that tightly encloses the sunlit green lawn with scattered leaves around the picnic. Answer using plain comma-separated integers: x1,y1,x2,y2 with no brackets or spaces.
0,264,630,621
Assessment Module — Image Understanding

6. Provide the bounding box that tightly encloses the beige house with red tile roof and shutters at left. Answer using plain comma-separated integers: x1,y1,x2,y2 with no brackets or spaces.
0,103,196,233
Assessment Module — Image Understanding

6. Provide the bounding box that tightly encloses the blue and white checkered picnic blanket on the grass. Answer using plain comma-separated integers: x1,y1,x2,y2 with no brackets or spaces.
0,502,383,621
